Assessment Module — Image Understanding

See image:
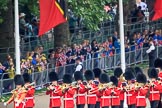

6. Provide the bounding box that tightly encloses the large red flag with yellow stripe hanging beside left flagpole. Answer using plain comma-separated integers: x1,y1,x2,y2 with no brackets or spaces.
39,0,66,36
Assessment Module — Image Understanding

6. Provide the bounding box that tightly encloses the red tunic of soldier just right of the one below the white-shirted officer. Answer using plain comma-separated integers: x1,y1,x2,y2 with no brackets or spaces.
87,84,98,104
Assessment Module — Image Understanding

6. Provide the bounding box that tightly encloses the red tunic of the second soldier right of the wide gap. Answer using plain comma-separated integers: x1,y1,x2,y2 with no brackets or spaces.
63,87,75,108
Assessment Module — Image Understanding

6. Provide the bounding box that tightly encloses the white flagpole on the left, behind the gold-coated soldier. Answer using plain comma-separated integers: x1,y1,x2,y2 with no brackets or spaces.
15,0,21,74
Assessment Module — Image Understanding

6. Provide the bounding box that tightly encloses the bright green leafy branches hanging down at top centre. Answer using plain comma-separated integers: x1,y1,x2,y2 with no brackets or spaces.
68,0,114,30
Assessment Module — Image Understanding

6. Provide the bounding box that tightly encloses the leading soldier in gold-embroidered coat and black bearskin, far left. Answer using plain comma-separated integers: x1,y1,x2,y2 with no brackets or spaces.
4,75,27,108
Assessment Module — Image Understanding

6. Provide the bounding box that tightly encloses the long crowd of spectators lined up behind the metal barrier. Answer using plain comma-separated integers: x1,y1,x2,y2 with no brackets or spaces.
0,30,162,78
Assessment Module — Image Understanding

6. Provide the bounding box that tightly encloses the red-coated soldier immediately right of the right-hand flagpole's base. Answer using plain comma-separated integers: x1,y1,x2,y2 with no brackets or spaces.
124,68,136,108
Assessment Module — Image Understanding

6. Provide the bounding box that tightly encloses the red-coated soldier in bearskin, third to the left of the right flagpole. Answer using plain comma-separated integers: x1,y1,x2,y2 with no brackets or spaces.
99,73,111,108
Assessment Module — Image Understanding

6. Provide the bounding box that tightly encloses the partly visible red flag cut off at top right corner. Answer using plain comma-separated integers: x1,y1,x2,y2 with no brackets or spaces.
152,0,162,21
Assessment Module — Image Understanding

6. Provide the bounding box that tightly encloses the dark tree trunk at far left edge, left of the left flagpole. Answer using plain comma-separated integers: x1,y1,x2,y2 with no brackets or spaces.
0,0,14,47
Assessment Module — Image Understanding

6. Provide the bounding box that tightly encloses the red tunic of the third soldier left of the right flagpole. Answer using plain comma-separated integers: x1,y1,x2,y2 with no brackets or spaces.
101,88,111,107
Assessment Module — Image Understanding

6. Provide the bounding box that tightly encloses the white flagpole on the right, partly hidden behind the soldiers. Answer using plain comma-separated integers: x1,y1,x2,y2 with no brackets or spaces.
119,0,128,108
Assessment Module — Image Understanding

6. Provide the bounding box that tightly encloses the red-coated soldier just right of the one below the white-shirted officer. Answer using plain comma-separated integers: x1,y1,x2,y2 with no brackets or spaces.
84,70,98,108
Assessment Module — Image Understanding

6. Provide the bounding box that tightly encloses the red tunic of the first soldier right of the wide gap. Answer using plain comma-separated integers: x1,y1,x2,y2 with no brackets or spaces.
46,86,62,108
